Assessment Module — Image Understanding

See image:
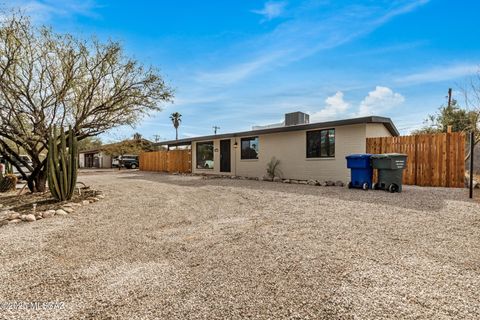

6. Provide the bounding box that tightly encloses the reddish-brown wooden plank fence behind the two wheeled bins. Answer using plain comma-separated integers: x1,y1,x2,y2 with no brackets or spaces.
367,132,465,188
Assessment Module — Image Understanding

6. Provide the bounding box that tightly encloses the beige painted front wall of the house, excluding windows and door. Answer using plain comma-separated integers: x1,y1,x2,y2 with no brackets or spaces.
192,124,382,182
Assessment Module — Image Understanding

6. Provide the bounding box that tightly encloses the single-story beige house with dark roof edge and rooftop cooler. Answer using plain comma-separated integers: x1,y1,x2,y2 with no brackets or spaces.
157,112,399,182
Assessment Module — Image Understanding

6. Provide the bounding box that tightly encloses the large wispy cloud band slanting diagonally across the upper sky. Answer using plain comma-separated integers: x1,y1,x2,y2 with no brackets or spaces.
197,0,428,86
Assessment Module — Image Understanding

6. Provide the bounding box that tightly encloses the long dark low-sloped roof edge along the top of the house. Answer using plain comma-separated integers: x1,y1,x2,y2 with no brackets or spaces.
154,116,399,146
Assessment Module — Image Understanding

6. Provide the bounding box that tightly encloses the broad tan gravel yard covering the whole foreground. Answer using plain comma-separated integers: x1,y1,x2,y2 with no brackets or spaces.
0,171,480,319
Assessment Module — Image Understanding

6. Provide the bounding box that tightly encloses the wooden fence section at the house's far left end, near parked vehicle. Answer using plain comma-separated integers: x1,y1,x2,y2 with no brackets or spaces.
140,150,192,173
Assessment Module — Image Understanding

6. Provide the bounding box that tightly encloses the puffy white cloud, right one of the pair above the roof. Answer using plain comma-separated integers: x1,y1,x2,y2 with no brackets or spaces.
357,86,405,116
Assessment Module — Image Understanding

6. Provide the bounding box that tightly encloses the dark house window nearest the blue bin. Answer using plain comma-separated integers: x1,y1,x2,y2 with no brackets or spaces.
307,129,335,158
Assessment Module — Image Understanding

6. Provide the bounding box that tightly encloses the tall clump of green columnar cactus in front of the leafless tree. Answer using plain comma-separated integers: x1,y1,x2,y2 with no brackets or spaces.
47,127,78,201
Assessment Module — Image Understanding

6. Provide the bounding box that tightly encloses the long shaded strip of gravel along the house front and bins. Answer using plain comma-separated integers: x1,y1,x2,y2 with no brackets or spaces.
119,171,470,212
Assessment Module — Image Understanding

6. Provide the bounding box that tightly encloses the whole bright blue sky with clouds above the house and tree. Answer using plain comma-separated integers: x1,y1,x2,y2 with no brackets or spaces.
9,0,480,140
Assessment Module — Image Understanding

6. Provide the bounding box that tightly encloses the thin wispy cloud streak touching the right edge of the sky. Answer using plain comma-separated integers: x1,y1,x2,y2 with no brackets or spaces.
395,64,480,85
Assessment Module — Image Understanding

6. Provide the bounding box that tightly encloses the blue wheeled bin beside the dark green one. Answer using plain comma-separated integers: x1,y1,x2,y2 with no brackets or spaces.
345,153,373,190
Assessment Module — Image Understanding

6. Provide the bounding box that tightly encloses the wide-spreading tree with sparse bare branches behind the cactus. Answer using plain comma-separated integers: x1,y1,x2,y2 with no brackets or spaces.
0,14,173,192
